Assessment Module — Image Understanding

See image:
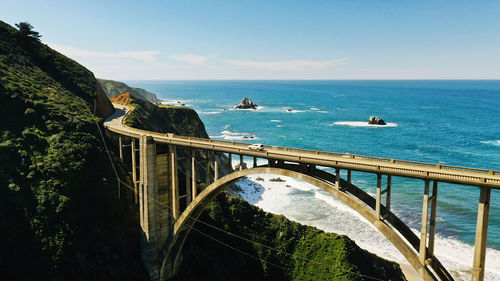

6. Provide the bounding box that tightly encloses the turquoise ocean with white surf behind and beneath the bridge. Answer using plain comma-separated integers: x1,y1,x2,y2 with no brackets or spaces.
127,80,500,280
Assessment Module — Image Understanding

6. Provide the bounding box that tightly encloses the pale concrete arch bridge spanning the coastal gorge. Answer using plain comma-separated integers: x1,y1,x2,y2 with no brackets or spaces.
105,105,500,280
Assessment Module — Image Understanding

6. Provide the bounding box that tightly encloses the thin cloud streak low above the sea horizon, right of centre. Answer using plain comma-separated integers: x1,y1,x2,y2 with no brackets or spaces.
224,58,348,71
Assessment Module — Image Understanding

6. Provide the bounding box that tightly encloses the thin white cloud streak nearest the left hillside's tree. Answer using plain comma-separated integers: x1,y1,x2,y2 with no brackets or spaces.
47,43,160,62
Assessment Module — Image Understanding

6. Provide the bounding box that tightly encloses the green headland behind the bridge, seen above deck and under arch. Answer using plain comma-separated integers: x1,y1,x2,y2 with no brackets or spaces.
120,94,405,281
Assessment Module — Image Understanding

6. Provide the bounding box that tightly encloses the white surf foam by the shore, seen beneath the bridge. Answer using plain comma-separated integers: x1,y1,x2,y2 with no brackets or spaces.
233,175,500,281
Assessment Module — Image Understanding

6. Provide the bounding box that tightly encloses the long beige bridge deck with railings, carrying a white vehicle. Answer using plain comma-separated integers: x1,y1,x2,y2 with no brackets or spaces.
104,105,500,189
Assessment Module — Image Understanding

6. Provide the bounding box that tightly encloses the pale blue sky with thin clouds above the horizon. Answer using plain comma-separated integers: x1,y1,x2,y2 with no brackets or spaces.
0,0,500,80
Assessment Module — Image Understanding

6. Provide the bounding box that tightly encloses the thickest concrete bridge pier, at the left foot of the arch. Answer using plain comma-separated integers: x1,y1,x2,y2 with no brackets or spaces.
137,136,186,281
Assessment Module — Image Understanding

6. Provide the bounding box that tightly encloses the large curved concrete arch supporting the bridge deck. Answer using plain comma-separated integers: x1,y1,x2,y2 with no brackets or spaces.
160,164,453,280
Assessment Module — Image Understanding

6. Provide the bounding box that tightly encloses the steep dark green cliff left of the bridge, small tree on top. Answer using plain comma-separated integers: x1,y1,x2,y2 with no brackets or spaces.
0,22,146,280
